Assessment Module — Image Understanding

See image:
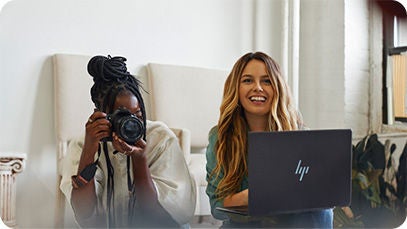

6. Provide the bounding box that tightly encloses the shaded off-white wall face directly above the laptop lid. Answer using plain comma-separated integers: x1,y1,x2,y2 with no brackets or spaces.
299,0,345,128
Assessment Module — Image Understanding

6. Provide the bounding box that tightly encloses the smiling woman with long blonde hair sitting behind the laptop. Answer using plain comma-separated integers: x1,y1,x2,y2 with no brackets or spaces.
206,52,332,228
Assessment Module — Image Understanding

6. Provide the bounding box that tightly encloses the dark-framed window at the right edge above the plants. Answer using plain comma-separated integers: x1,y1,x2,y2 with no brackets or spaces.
379,1,407,125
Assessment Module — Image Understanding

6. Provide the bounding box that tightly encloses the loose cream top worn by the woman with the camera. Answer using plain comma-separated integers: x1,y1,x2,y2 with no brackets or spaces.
60,121,196,227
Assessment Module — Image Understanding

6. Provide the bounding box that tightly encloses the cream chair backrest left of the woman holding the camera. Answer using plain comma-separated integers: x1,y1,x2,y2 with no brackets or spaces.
53,54,94,169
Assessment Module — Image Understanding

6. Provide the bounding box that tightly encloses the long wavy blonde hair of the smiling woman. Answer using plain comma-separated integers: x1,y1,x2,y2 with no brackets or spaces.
212,52,302,199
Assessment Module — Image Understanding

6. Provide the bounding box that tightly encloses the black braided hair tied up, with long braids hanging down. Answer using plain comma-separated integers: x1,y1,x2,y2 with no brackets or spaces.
88,55,146,226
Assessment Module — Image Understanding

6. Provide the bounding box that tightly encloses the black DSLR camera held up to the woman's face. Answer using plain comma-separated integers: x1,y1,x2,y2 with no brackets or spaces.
105,108,145,145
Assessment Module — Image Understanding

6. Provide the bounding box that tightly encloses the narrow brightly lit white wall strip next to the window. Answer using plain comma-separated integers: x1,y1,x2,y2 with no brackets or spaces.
345,0,371,136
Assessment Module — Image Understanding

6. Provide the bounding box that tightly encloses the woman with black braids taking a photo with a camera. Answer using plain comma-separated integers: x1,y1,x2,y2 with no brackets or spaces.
61,56,195,227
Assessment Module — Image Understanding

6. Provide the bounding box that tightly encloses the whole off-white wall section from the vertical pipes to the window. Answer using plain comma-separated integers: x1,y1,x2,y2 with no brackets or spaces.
299,0,381,137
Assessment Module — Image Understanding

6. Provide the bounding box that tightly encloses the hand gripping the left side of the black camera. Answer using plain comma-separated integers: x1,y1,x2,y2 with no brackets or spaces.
85,110,111,147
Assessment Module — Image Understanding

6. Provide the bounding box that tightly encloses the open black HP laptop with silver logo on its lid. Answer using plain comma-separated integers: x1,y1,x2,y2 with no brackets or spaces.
217,129,352,216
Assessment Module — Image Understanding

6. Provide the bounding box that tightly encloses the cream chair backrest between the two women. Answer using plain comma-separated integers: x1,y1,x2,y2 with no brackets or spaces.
147,63,228,151
